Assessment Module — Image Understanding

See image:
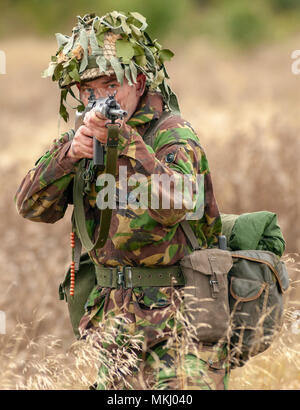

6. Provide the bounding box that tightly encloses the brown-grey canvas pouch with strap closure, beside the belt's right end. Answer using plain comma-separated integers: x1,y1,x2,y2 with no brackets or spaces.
180,248,232,343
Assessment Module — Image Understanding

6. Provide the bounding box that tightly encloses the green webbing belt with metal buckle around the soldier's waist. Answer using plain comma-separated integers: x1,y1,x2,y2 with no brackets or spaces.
95,265,185,289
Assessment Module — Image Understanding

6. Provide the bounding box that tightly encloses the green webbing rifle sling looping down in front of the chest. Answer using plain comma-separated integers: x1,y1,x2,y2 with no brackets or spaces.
73,125,119,252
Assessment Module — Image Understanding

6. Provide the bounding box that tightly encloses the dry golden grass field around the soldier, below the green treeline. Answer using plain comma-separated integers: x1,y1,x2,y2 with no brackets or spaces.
0,37,300,389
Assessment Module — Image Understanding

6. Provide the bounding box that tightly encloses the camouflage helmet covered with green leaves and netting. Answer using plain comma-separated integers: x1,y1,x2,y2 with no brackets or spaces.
42,11,179,121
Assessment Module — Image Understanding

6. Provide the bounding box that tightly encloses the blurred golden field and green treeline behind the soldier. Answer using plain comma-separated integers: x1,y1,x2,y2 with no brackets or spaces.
0,0,300,389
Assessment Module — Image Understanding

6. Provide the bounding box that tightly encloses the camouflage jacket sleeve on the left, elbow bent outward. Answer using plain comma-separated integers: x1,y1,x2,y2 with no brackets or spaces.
15,133,76,223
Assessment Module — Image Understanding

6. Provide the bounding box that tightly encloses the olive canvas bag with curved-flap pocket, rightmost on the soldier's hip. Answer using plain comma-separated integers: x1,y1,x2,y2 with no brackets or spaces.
228,250,289,368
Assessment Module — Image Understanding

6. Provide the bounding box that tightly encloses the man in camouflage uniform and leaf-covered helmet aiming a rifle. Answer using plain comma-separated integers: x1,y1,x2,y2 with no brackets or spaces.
16,11,228,389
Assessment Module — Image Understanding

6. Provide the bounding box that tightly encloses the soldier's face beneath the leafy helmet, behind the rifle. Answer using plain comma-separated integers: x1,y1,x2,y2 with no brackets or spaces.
78,74,146,120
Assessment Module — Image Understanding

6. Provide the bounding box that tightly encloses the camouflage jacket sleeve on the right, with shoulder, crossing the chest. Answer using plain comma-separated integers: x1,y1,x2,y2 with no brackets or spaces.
120,116,219,231
